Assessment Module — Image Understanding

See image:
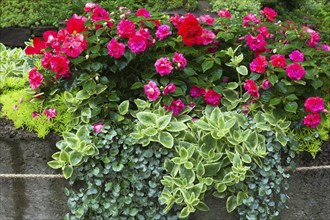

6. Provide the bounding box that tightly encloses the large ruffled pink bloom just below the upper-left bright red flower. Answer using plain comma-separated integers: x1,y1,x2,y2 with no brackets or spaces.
62,34,87,58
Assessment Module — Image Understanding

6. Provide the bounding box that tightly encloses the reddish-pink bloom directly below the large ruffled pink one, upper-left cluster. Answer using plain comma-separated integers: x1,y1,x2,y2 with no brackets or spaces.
50,55,70,78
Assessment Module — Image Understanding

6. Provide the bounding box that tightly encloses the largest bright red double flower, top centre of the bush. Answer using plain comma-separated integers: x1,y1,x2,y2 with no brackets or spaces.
178,14,203,46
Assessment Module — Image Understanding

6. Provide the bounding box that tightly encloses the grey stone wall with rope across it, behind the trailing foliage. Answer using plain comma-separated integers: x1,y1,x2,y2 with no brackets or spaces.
0,119,330,220
